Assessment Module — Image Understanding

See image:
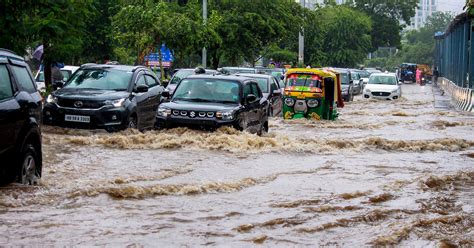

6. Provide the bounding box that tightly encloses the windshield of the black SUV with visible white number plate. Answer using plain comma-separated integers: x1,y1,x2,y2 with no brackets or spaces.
64,69,133,91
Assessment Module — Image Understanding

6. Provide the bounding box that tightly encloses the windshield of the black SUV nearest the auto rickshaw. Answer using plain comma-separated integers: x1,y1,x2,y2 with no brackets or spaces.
172,78,240,103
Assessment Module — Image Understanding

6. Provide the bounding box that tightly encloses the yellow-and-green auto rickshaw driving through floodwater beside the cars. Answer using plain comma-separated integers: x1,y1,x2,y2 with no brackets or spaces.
283,68,344,120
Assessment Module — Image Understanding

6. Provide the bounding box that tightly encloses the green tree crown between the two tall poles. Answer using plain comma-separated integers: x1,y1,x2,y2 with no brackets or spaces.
210,0,302,67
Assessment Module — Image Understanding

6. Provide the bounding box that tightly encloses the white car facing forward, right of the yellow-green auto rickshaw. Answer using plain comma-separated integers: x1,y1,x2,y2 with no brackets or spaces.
364,73,402,100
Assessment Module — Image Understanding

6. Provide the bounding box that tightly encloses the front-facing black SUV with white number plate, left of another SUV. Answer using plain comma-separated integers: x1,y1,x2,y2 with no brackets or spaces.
43,64,164,131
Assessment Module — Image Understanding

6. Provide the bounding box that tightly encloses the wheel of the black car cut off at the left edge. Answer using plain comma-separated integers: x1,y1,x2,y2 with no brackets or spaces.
18,144,41,185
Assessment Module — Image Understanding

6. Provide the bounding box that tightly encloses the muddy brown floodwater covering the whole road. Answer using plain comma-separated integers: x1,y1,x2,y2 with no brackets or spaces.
0,85,474,247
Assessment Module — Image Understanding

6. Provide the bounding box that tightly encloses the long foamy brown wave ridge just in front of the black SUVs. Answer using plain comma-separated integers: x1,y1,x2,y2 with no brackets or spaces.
46,127,474,153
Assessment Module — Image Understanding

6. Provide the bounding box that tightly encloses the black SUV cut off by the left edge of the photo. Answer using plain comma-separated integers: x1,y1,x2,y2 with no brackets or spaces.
0,49,42,185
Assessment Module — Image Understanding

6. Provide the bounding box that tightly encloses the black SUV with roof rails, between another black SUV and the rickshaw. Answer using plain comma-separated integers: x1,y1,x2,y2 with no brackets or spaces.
155,75,269,135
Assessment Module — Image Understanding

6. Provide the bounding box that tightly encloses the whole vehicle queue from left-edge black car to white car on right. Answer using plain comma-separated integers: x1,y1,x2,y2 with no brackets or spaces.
0,49,401,185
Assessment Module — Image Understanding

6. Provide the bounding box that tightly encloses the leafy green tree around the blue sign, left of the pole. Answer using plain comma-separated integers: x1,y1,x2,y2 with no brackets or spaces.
113,0,220,74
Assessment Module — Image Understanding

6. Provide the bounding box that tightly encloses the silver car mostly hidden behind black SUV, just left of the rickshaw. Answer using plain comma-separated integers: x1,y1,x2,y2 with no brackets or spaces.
236,73,283,116
